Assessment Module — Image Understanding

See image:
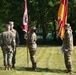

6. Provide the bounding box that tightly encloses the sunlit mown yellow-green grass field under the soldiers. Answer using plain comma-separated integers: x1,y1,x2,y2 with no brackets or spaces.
0,46,76,75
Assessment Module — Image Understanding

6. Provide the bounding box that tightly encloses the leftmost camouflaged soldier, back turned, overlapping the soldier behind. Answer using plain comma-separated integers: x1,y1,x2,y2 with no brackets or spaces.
1,25,14,70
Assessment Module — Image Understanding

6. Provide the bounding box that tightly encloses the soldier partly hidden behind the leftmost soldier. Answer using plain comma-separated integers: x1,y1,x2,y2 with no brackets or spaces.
9,21,20,68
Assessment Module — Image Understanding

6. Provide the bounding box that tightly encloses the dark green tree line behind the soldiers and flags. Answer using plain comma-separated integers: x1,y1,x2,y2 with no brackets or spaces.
0,0,76,44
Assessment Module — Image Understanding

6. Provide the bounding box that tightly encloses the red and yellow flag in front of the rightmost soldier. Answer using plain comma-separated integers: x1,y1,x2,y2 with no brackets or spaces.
58,0,68,39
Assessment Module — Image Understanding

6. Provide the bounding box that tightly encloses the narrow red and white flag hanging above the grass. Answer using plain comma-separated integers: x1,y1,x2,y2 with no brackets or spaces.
23,0,28,32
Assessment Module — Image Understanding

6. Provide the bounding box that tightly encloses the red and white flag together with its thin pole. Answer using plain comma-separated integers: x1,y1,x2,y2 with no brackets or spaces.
23,0,29,67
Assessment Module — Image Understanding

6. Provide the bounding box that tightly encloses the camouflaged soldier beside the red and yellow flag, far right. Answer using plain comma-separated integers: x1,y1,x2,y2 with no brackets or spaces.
62,23,73,74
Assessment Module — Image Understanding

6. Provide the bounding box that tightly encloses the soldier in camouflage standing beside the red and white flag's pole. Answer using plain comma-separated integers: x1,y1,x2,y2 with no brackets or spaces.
27,27,37,70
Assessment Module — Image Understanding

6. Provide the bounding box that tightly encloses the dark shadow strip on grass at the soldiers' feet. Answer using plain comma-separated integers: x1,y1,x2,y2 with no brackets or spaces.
15,67,65,73
